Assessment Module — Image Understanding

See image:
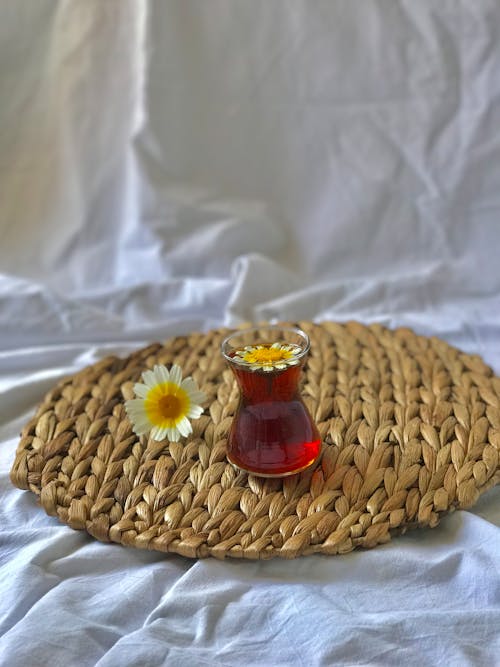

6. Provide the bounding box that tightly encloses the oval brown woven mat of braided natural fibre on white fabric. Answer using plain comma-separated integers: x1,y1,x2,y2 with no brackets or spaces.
11,322,500,559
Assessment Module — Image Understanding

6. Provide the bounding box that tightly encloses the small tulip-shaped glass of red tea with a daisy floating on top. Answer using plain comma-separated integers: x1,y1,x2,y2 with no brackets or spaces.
222,326,321,477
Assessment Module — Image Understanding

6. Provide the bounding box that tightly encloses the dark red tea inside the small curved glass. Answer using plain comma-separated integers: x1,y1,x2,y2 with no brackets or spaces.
228,345,321,477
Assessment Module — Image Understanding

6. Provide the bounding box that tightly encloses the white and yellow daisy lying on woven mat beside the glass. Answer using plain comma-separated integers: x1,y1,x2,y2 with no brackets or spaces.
125,364,206,442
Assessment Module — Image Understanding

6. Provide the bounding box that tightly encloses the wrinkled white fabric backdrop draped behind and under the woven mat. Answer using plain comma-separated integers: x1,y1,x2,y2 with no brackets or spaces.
0,0,500,667
